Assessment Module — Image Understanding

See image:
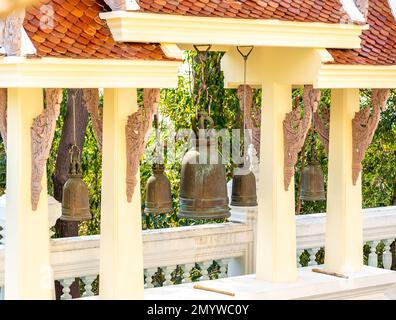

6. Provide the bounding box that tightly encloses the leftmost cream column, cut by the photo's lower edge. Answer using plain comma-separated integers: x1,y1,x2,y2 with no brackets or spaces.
5,89,54,299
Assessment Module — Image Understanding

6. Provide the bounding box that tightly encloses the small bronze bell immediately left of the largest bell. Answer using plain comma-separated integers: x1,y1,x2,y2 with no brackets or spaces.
144,163,173,214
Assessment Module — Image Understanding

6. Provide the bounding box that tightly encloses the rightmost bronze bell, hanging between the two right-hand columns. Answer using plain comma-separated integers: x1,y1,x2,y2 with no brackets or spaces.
300,142,326,201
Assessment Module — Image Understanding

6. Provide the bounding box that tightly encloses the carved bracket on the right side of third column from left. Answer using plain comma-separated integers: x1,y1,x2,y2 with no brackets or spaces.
283,85,320,191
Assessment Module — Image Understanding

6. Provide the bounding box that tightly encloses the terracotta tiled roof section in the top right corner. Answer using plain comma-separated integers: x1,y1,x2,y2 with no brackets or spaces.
329,0,396,65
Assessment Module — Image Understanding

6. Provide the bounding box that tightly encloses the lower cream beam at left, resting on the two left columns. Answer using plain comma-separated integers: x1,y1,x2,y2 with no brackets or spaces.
0,57,182,88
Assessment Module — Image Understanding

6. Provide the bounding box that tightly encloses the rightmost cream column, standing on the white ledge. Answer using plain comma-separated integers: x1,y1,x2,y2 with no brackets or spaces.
325,89,363,273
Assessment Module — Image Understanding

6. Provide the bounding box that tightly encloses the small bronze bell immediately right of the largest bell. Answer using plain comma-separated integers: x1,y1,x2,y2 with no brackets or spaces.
231,165,257,207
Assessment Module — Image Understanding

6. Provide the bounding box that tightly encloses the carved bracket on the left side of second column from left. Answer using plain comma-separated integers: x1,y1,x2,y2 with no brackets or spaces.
83,89,103,151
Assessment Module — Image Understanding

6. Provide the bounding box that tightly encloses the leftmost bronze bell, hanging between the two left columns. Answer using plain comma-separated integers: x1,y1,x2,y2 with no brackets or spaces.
61,146,92,222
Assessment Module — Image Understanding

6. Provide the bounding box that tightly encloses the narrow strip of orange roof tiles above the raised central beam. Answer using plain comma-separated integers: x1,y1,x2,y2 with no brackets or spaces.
139,0,349,23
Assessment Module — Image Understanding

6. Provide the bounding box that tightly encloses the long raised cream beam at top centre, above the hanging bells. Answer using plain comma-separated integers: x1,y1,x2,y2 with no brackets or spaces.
100,11,367,48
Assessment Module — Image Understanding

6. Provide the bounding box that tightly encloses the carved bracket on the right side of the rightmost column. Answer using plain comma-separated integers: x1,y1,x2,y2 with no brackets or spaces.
352,89,390,185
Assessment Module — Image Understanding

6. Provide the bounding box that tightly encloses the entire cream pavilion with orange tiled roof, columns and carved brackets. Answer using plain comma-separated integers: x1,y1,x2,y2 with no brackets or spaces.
0,0,396,299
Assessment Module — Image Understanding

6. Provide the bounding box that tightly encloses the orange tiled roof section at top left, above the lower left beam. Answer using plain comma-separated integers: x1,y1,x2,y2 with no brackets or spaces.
24,0,172,60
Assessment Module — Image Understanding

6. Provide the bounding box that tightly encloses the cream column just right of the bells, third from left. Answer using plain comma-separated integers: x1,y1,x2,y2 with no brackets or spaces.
256,83,297,282
